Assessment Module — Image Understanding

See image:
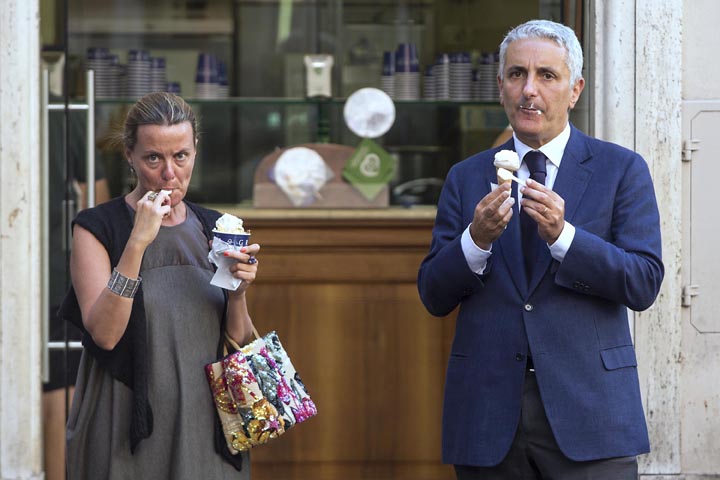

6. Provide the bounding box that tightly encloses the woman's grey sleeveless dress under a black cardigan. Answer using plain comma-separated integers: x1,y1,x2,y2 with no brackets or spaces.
67,207,250,480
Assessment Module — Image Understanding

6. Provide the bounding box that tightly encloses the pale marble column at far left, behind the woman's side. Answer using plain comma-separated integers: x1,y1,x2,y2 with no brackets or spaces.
0,0,44,480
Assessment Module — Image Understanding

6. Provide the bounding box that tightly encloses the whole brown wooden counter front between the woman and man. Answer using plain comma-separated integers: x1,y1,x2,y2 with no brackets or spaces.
240,220,454,479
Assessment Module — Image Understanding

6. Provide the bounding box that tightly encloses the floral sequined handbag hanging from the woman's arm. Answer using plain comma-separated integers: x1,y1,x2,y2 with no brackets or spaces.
205,327,317,455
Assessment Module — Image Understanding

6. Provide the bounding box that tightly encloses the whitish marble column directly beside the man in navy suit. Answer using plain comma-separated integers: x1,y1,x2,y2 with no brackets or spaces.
588,0,683,478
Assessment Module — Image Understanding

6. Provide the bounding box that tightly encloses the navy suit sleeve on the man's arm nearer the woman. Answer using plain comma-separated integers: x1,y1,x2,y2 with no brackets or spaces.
418,169,490,316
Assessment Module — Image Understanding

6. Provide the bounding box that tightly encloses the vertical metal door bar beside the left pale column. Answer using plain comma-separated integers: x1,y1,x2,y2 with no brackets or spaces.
40,68,50,383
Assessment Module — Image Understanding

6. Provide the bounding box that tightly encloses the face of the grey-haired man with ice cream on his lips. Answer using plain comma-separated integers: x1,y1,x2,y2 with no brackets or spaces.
498,38,585,148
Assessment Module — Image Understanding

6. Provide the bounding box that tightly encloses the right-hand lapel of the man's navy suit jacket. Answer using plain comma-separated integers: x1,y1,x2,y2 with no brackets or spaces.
528,127,592,293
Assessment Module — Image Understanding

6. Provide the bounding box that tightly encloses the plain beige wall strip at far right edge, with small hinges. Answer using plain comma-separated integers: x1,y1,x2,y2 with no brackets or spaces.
680,0,720,478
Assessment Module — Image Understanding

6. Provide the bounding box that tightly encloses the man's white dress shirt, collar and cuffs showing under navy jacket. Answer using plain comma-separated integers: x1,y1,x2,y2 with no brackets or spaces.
460,123,575,275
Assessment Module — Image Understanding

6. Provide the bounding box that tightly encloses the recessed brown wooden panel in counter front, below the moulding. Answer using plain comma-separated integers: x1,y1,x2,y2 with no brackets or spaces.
252,284,445,462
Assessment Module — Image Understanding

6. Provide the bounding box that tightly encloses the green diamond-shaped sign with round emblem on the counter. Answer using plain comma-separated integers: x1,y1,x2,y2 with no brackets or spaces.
343,138,395,201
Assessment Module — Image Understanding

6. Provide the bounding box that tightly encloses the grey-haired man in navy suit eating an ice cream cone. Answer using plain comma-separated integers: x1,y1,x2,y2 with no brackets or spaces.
418,20,664,480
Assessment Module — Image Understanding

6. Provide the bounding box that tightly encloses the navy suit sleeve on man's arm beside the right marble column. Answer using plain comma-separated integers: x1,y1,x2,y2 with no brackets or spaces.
555,154,664,311
